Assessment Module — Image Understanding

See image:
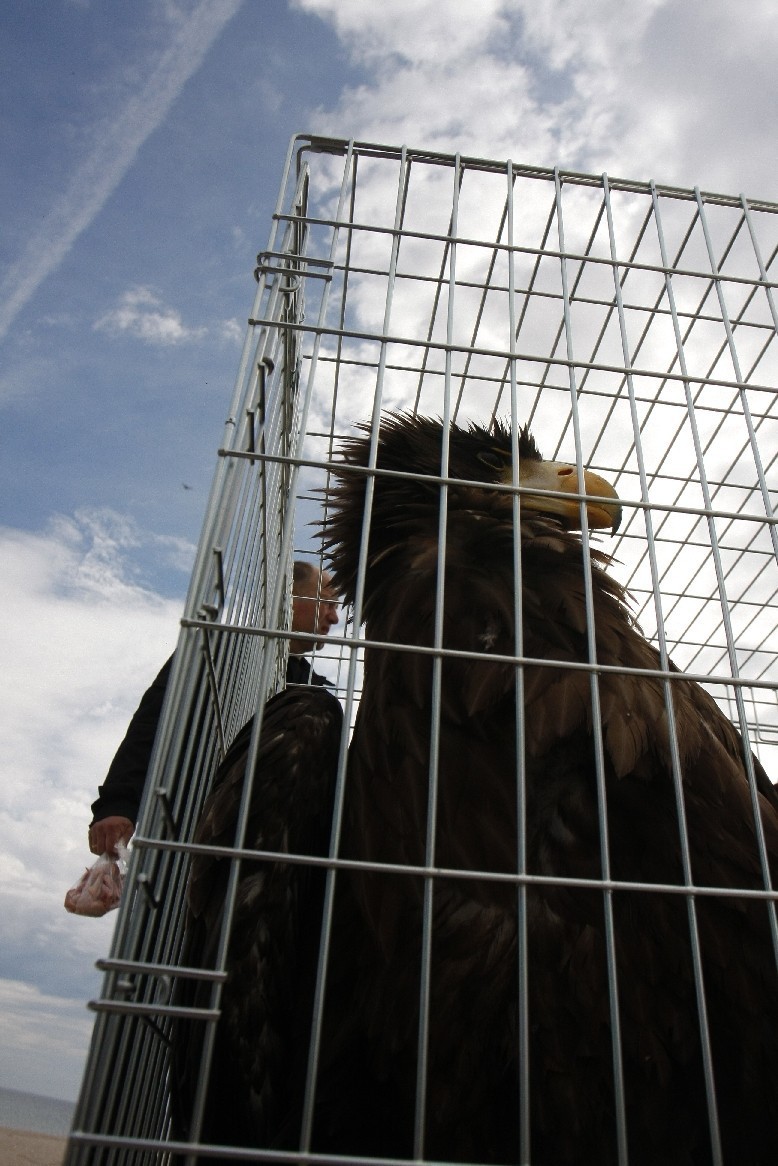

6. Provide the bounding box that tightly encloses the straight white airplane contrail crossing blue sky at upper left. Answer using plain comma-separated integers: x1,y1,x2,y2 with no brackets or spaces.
0,0,243,339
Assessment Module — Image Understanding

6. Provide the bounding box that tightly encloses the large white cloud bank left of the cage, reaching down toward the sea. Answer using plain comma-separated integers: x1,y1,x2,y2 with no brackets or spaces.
0,511,181,1095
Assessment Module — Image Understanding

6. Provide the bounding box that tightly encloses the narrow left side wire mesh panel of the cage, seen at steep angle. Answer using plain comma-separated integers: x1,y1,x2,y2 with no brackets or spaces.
68,145,319,1161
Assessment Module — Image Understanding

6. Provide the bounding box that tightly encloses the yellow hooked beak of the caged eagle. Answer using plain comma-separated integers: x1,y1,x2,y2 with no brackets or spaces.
519,459,622,534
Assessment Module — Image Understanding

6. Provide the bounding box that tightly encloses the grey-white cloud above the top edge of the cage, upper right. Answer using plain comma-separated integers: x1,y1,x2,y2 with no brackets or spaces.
295,0,778,198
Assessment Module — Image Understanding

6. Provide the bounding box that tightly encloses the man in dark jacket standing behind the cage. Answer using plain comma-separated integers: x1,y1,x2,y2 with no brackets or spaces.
89,560,338,855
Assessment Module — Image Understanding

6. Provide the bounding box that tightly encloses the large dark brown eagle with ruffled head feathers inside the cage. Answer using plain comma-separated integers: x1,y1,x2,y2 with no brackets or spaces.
173,414,778,1166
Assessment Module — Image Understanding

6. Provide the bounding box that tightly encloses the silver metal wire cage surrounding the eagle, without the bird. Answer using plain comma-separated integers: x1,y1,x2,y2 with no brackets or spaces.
66,136,778,1166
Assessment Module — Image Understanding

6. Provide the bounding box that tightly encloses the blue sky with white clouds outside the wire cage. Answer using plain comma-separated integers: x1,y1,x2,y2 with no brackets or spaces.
0,0,778,1098
